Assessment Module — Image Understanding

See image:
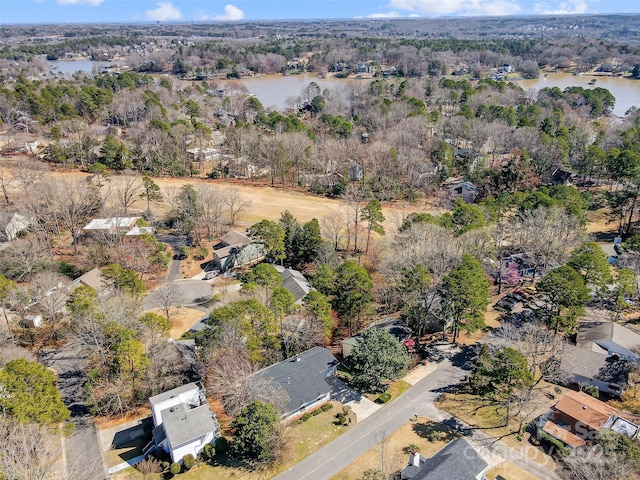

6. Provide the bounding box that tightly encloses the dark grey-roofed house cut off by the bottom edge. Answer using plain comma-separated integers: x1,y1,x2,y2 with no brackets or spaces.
399,438,489,480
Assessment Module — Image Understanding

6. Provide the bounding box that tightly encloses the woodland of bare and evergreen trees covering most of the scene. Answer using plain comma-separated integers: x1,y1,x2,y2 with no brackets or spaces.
0,16,640,478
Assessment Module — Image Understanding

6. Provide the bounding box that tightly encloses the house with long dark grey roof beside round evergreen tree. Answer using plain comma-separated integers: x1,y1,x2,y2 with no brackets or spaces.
255,347,338,421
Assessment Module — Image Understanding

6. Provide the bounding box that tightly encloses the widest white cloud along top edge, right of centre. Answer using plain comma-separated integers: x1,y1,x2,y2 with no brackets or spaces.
389,0,524,16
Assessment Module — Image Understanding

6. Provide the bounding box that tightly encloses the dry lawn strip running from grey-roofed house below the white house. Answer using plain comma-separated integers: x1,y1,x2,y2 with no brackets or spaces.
116,403,348,480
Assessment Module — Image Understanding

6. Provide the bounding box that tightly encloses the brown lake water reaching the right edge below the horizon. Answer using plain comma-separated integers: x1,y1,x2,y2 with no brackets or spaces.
514,73,640,117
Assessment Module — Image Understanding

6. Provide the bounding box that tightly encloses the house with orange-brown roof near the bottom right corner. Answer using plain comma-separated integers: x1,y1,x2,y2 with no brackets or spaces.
538,390,640,448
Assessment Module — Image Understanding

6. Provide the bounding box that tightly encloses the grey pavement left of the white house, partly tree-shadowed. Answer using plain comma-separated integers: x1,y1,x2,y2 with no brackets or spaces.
40,343,106,480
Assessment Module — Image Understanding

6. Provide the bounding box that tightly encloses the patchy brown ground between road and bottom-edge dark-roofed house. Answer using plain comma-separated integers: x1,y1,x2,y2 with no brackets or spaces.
332,417,454,480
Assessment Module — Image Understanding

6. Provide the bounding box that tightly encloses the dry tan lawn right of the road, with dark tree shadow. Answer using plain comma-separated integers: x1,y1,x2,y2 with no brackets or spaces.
332,417,458,480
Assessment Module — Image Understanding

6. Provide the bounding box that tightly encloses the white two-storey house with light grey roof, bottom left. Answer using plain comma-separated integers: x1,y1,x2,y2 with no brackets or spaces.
149,383,221,462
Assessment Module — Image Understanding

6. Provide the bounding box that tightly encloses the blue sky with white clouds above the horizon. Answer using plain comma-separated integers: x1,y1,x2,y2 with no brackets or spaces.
0,0,640,25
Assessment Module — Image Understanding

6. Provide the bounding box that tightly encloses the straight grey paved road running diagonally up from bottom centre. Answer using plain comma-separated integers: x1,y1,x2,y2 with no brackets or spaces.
275,362,464,480
